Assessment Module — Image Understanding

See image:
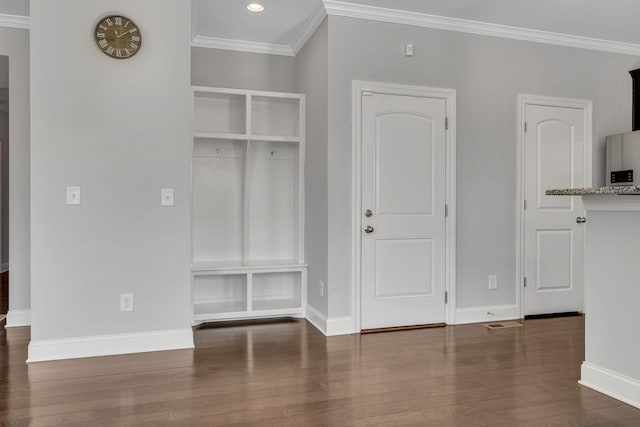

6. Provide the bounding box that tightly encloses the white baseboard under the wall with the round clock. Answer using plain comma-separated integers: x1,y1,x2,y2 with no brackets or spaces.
27,328,194,363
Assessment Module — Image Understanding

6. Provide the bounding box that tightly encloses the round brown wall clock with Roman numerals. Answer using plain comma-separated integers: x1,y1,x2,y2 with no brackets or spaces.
95,15,142,59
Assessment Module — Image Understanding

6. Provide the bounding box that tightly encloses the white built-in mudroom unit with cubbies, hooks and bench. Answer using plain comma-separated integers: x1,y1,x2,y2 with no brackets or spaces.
192,87,306,323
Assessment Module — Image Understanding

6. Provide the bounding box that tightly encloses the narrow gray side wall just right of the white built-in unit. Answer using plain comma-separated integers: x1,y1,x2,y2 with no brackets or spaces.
295,20,329,316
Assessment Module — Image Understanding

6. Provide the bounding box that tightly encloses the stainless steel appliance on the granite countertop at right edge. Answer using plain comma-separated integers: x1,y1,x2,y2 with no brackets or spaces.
606,130,640,187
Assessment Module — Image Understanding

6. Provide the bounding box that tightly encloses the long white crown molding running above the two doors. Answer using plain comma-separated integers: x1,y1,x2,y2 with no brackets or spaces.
324,0,640,56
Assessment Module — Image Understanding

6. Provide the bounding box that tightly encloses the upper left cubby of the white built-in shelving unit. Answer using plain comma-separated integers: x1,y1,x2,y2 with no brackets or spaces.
193,90,247,135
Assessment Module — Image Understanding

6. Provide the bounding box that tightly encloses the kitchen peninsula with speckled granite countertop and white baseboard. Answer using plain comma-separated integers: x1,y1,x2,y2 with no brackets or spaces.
546,186,640,408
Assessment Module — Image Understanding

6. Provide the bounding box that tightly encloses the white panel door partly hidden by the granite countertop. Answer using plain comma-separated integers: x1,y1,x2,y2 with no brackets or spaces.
524,105,586,315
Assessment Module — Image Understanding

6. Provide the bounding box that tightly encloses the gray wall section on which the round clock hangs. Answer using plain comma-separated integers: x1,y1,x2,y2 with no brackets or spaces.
30,0,192,343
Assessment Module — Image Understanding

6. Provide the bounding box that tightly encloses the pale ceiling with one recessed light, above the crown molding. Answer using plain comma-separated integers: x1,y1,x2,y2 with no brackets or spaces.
0,0,640,55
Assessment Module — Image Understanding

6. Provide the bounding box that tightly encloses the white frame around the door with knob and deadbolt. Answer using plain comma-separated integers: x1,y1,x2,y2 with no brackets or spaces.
351,80,456,333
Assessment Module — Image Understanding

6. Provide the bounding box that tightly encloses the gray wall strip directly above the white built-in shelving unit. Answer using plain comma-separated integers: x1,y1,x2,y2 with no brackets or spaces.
191,47,295,92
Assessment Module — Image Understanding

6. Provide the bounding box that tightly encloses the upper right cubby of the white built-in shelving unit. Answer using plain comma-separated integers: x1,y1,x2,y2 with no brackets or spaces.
251,95,300,138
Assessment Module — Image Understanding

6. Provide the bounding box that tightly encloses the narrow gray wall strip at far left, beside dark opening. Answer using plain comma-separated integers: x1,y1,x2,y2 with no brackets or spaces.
0,28,31,326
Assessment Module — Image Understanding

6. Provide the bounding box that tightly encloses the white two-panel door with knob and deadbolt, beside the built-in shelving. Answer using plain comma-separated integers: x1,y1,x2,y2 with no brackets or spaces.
361,93,446,329
